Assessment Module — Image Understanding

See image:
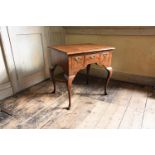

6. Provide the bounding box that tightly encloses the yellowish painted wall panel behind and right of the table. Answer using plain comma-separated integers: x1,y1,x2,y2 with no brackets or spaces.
66,34,155,77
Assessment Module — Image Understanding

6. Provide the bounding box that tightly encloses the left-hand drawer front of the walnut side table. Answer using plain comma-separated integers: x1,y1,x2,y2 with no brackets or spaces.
71,56,84,68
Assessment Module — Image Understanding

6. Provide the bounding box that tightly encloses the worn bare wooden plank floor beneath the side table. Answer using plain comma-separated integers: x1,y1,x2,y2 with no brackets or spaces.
0,74,155,129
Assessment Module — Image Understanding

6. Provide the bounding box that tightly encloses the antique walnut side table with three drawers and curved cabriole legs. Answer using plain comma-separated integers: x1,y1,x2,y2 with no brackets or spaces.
48,43,115,109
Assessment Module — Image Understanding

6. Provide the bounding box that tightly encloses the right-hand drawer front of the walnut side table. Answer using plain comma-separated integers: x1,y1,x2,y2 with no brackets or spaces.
100,52,112,67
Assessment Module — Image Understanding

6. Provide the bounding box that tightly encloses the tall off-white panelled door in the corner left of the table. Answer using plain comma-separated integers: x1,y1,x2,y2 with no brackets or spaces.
8,26,48,91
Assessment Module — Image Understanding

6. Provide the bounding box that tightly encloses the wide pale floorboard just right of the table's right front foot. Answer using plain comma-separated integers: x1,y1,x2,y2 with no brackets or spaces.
96,84,134,128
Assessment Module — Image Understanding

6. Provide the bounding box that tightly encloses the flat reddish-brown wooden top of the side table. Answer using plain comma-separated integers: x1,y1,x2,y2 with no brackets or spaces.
48,43,115,55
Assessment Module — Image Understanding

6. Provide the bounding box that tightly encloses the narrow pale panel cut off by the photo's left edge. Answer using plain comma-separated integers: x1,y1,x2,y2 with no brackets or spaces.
0,31,13,100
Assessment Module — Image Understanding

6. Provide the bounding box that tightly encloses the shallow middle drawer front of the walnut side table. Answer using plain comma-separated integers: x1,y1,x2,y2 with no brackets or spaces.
85,54,100,64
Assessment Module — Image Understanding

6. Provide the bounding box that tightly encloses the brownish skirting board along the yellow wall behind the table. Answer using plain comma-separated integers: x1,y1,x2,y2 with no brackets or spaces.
81,68,155,86
